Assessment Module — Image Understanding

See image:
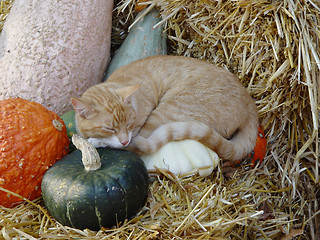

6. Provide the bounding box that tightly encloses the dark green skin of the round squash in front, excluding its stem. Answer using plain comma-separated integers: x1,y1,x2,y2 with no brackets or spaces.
41,148,149,231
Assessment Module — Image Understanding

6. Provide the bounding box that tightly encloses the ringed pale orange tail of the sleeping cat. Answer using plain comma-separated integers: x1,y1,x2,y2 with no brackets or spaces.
134,122,258,161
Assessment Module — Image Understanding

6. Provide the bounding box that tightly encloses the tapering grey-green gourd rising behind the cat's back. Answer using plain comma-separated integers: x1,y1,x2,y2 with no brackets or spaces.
105,9,167,80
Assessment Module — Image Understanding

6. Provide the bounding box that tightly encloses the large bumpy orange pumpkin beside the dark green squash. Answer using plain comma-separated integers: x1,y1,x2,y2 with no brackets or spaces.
0,98,69,207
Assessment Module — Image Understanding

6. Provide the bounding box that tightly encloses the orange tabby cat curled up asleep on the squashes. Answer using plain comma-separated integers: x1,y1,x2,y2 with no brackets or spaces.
71,55,258,161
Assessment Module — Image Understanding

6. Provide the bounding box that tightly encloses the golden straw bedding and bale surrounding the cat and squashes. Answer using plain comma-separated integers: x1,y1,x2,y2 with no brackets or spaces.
0,0,320,239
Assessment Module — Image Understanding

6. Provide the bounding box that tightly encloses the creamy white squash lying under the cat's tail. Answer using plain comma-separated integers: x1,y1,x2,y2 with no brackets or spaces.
141,139,220,176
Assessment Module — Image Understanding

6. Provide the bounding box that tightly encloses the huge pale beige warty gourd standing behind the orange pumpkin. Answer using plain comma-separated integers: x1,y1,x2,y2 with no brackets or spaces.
0,0,113,114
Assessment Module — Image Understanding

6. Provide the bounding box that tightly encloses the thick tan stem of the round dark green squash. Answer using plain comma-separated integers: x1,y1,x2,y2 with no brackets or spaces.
72,134,101,171
